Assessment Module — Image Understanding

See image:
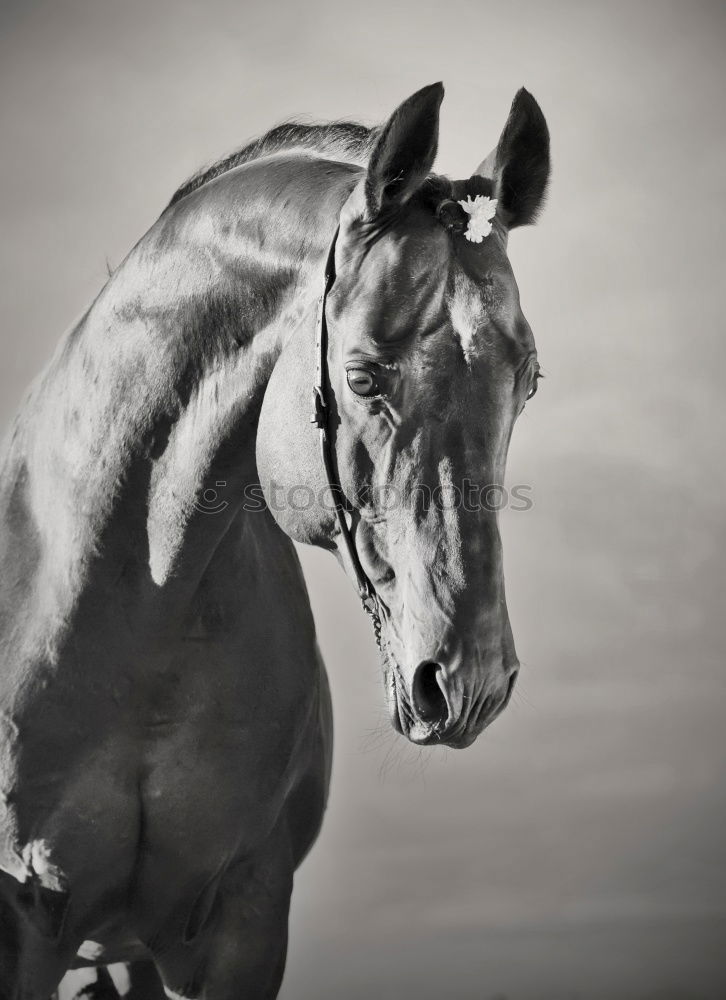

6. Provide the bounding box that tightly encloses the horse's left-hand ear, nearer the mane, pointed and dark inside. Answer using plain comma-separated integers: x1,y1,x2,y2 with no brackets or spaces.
365,83,444,219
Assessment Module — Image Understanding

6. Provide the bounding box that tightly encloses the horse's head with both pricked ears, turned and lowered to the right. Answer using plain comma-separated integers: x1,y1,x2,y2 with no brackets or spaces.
257,84,549,747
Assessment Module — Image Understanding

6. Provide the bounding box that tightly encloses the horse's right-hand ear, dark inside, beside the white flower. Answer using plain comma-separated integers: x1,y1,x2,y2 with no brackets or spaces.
475,87,550,229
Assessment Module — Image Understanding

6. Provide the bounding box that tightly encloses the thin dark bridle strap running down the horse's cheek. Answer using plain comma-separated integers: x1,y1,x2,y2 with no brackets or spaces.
310,226,381,649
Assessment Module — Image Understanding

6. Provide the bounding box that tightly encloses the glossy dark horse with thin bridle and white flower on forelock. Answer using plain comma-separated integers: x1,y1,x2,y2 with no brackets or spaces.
0,84,549,1000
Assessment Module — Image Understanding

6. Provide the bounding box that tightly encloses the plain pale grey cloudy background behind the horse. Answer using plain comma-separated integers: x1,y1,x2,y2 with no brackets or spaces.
0,0,726,1000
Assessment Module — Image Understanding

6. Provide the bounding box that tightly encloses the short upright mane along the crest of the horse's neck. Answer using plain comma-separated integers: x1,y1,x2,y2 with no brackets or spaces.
167,120,380,208
